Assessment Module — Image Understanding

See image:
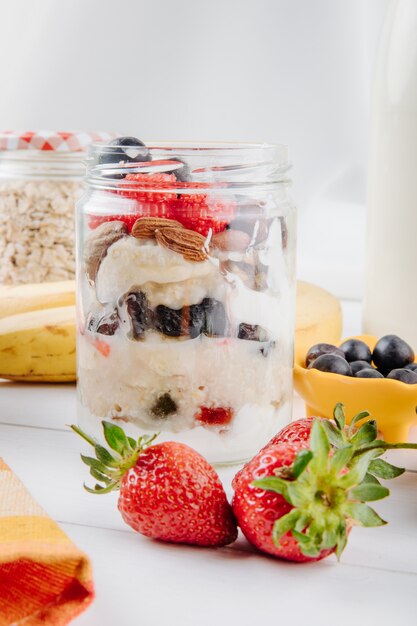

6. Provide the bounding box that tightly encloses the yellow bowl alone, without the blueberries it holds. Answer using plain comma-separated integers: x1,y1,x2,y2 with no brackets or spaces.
294,335,417,443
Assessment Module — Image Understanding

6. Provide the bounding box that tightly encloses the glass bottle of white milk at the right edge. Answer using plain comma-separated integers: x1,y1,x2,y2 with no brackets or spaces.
363,0,417,350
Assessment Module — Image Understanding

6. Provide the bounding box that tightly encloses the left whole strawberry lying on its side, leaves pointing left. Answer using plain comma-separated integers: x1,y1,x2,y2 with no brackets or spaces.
71,421,237,546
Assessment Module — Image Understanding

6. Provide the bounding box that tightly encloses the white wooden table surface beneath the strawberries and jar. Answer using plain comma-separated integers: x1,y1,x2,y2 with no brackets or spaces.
0,303,417,626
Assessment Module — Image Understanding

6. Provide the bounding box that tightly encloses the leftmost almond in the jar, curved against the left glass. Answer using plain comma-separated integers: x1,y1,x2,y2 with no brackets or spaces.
84,220,128,282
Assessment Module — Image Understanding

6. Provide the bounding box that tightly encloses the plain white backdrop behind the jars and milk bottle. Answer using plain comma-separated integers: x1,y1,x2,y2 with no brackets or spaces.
0,0,387,298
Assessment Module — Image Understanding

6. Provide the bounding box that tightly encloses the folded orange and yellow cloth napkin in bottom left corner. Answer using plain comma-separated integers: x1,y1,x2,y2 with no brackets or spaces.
0,459,94,626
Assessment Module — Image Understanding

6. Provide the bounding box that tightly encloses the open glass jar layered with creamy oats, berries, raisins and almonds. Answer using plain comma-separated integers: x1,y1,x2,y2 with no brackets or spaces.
77,137,295,463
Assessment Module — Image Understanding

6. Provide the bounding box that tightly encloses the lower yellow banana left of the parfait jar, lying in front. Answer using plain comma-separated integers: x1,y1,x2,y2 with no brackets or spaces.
0,306,76,382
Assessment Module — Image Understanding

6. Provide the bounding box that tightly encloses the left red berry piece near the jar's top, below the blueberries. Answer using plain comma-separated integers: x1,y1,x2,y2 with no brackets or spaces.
88,174,177,232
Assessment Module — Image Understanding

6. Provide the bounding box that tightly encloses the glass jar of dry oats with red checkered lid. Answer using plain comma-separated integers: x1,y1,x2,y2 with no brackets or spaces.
0,130,114,284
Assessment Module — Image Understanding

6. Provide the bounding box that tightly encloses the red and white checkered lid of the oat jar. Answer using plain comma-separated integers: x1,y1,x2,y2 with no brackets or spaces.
0,130,117,152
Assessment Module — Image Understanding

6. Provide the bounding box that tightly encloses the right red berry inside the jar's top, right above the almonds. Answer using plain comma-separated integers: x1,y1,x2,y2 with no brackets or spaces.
175,182,236,237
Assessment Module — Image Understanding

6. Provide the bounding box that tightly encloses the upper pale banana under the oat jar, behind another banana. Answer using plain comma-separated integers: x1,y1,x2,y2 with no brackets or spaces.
0,280,75,319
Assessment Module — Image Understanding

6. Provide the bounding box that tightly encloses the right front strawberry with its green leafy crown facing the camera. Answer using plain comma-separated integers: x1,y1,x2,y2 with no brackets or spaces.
233,404,417,562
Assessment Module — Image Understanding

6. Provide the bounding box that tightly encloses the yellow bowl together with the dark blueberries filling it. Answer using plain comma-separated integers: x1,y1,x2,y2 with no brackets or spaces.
294,335,417,443
